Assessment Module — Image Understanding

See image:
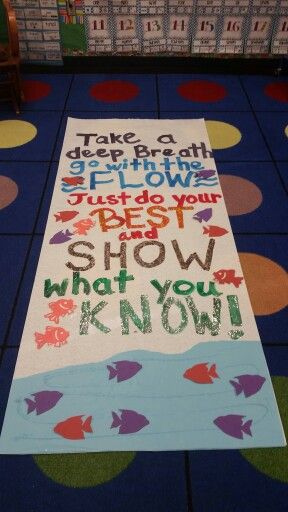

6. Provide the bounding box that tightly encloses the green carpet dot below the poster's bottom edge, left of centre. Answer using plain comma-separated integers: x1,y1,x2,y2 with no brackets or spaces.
33,452,136,488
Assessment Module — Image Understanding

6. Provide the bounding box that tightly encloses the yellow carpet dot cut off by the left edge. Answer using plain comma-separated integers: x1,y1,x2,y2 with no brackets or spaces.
0,120,37,149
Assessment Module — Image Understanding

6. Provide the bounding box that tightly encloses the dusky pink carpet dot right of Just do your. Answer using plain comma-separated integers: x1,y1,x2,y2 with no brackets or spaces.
219,174,263,216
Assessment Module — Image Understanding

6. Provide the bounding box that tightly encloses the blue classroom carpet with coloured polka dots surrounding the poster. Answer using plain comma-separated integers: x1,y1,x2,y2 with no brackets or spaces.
0,74,288,512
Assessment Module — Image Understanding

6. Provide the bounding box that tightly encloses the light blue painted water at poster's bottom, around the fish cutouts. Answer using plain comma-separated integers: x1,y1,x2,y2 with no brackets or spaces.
0,342,285,453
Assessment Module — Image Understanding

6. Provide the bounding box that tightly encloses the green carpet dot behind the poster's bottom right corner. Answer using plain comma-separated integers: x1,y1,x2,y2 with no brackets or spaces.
241,377,288,483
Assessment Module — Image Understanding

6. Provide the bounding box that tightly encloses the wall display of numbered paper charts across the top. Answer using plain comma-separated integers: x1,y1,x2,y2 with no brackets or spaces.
1,0,288,62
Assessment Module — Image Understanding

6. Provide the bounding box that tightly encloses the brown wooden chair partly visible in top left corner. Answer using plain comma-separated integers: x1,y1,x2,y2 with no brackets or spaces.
0,0,24,114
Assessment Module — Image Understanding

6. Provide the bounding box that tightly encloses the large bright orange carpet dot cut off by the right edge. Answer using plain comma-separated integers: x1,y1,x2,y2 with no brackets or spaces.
239,252,288,316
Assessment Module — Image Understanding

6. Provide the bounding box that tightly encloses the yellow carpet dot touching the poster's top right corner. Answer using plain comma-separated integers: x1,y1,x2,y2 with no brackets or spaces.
206,121,242,149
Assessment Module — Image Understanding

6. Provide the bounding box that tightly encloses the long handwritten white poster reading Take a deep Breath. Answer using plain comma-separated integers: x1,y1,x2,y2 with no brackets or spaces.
0,118,285,454
